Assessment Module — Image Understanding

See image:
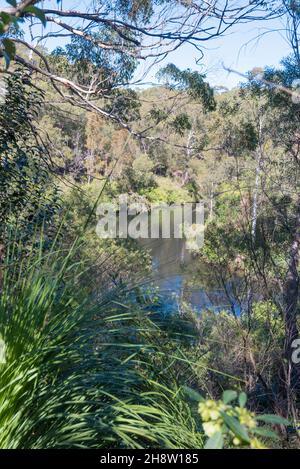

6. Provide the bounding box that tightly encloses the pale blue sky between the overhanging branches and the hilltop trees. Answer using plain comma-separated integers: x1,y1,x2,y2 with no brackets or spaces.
0,0,290,88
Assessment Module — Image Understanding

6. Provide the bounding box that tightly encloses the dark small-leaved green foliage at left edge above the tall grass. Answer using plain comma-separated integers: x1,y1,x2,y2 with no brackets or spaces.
0,70,58,243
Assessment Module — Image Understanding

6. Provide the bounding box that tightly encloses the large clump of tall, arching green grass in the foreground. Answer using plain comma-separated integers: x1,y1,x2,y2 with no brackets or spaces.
0,239,203,448
